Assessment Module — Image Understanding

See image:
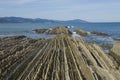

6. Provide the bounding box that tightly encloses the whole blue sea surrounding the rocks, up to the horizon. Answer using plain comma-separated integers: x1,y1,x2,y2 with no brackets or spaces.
0,22,120,51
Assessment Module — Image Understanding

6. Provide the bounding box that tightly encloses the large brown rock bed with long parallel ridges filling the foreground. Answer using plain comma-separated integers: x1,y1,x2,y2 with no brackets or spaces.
0,26,120,80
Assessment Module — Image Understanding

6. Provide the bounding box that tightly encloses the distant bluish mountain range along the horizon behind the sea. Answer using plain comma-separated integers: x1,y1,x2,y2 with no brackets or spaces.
0,17,87,24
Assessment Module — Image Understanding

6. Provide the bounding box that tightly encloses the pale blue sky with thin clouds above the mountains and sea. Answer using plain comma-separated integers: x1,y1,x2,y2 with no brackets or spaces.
0,0,120,22
